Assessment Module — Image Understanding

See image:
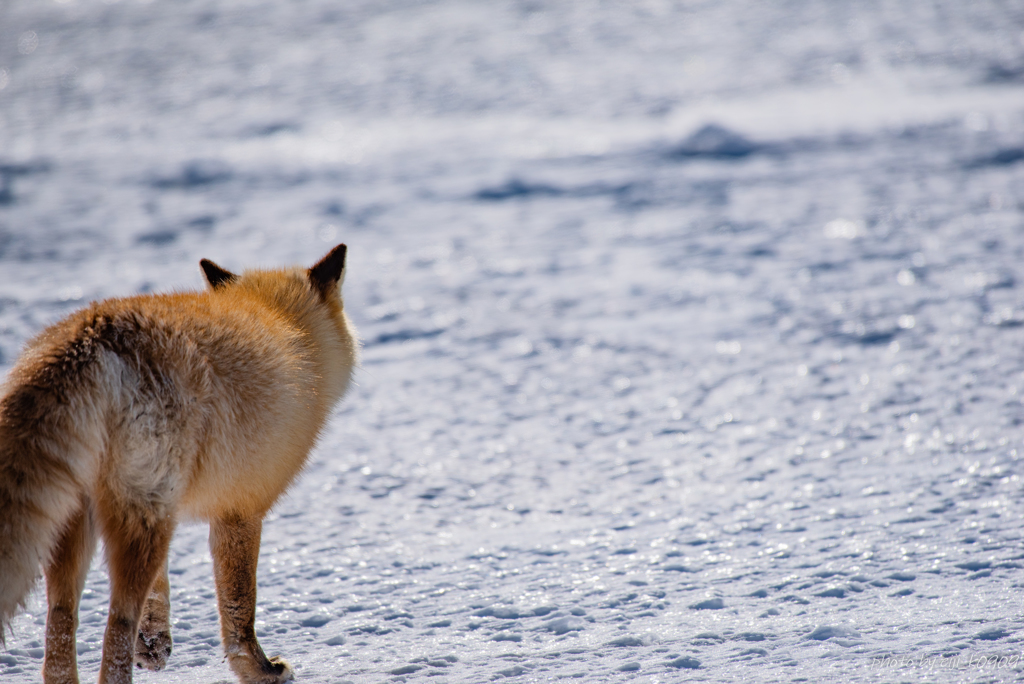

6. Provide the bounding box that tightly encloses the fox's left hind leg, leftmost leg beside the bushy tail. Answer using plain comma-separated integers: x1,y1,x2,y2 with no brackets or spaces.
43,498,96,684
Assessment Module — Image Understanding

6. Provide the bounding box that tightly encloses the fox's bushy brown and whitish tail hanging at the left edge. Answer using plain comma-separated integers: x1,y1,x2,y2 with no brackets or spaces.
0,369,95,645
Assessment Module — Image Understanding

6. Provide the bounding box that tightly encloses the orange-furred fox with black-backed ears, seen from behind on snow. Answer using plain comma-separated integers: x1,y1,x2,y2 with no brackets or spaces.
0,245,359,684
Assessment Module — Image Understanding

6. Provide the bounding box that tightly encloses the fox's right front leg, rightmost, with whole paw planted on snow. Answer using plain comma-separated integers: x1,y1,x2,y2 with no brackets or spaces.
210,516,294,684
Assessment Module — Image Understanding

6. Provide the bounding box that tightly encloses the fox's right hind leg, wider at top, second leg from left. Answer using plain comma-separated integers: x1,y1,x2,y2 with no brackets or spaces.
99,510,174,684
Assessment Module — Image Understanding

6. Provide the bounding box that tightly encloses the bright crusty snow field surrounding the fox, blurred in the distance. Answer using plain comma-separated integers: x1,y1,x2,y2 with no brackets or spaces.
0,0,1024,684
